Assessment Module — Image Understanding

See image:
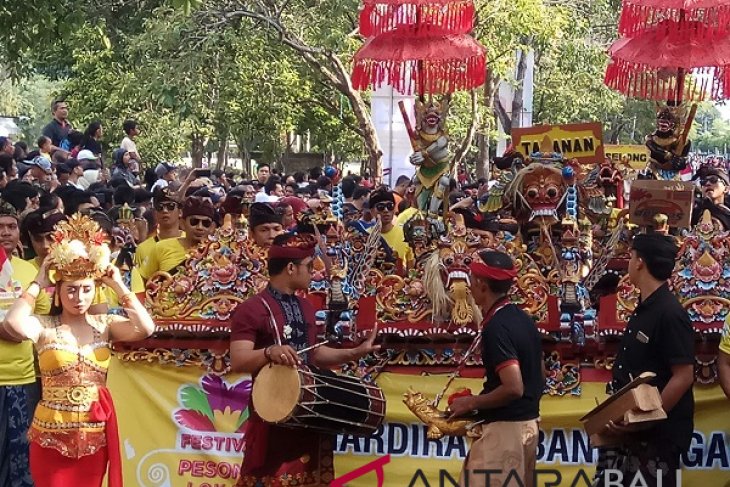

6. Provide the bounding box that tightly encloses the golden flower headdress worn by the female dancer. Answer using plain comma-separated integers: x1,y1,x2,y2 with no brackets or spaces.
49,213,111,282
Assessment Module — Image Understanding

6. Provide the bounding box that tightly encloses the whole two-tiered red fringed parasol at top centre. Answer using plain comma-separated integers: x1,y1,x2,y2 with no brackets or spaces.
352,0,487,95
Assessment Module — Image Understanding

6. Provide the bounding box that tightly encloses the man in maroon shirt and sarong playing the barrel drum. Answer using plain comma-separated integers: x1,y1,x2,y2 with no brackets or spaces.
230,233,380,487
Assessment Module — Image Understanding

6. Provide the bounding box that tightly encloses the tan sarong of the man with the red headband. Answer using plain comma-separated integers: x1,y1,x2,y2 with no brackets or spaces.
459,419,539,487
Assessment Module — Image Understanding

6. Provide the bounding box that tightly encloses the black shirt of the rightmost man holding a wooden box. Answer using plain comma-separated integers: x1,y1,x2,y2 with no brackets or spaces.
612,283,694,449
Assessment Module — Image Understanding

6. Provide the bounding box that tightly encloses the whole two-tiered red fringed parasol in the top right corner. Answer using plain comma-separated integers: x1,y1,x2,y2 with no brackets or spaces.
605,0,730,101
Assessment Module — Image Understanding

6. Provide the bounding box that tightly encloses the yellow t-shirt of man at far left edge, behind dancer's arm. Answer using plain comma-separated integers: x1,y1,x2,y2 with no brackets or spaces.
0,257,51,386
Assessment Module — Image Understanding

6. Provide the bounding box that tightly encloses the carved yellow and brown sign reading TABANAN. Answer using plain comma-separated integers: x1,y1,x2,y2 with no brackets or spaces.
512,122,604,164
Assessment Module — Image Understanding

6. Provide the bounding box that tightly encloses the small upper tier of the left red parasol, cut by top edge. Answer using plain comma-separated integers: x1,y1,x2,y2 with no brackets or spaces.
360,0,474,37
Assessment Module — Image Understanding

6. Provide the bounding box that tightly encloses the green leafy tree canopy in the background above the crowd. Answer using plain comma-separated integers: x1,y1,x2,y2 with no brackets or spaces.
0,0,730,172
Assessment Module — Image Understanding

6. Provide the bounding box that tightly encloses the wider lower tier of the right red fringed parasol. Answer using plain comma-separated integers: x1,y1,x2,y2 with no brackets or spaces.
605,19,730,101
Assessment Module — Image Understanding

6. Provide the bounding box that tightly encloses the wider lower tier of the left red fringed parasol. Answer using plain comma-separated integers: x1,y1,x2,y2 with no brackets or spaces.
352,27,486,94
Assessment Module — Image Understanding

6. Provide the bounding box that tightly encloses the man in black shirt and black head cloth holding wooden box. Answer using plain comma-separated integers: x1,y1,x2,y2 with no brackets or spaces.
597,233,694,486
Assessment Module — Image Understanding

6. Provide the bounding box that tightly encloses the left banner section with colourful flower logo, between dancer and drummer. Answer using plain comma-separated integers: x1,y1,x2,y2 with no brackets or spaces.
108,359,251,487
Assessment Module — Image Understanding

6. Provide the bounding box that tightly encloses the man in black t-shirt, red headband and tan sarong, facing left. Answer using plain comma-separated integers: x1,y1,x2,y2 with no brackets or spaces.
448,250,545,486
